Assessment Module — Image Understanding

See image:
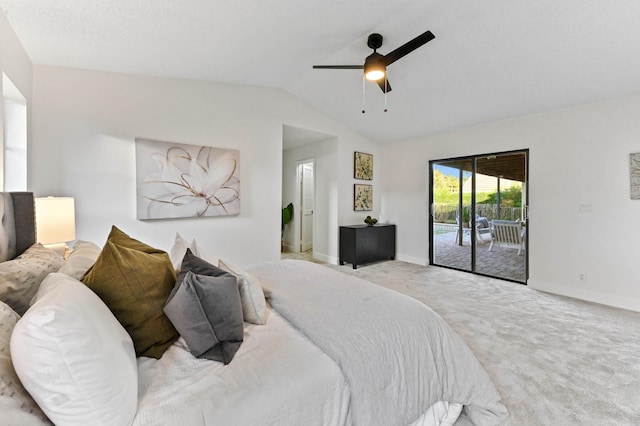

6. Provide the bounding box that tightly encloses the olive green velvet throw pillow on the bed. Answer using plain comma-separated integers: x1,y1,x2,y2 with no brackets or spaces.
82,226,178,358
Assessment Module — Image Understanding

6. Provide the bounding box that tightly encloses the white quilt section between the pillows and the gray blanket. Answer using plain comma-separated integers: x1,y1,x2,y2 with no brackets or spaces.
133,311,349,426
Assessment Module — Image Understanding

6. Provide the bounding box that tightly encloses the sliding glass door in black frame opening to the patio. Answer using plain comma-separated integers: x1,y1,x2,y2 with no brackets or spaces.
429,150,530,284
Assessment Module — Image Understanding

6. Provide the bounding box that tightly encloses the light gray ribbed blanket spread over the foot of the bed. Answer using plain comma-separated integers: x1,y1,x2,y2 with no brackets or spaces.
251,260,507,426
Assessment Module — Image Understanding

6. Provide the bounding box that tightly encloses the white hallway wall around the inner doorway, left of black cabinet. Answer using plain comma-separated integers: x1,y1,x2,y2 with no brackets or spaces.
282,138,340,263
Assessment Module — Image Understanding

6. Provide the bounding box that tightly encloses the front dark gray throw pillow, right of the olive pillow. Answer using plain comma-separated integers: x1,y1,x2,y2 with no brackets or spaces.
164,269,244,365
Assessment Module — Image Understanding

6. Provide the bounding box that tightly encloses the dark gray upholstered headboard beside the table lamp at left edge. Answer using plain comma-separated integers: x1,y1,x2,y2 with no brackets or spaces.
0,192,36,262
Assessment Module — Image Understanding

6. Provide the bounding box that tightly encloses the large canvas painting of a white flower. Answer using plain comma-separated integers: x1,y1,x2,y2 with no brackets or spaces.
136,138,240,220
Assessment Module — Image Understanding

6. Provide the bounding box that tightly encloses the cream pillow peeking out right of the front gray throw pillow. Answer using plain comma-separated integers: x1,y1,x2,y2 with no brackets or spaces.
218,260,267,325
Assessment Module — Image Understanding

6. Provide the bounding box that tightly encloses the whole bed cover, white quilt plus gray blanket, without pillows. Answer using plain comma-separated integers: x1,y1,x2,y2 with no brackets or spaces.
134,261,506,426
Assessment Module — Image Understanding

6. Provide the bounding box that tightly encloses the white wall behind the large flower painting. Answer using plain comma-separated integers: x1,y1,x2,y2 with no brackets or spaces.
29,66,372,264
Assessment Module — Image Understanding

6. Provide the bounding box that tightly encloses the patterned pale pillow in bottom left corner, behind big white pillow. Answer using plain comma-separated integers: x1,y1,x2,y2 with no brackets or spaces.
0,302,50,425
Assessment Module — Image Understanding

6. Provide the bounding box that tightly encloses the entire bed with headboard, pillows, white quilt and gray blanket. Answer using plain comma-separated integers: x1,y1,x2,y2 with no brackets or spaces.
0,193,507,426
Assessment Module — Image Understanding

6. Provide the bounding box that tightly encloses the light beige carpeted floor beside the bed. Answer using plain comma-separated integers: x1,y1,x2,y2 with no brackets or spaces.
283,251,640,426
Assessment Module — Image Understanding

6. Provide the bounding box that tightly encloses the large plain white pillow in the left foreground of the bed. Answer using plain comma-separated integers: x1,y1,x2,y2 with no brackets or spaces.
11,273,138,425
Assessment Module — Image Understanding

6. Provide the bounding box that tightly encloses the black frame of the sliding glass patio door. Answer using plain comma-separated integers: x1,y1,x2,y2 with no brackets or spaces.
428,148,531,285
